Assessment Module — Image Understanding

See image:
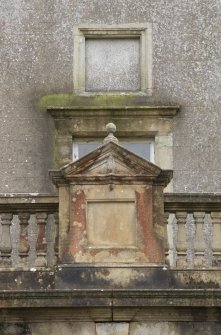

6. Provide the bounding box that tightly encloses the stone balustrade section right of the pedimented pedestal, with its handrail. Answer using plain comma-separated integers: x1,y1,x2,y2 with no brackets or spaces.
164,194,221,268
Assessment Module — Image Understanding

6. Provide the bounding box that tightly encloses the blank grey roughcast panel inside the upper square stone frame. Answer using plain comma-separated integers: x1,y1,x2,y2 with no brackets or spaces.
85,38,140,92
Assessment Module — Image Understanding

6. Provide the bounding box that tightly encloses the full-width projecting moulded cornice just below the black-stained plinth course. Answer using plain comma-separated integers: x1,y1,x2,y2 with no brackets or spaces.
0,289,221,308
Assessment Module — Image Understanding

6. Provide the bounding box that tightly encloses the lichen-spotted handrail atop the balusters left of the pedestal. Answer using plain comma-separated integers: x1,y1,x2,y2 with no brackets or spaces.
0,193,59,214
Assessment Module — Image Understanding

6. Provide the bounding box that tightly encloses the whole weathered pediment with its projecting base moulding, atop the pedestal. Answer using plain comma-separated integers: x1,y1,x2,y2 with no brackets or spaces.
50,141,172,185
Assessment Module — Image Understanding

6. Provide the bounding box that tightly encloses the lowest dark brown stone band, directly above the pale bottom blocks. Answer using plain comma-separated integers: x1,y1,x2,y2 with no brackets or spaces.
0,305,221,323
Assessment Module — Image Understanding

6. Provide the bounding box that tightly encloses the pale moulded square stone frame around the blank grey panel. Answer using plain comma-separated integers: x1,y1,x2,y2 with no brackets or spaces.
73,23,152,96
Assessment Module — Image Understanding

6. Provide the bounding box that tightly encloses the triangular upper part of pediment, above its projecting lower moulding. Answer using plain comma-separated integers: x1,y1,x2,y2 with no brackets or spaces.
61,142,161,178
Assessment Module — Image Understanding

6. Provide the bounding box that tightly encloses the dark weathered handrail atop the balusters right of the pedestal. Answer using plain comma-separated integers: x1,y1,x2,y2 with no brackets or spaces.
164,193,221,213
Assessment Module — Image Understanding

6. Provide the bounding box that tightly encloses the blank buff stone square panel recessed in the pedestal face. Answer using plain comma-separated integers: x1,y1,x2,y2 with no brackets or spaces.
87,201,136,248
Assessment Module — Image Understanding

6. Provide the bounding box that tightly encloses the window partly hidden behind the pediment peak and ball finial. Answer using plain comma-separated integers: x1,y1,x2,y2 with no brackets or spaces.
73,139,154,163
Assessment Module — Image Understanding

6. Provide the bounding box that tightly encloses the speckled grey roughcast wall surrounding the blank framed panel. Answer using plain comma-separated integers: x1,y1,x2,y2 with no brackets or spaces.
0,0,221,192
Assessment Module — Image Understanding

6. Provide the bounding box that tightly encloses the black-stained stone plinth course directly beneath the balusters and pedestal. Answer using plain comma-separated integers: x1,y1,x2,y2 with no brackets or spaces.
0,263,221,294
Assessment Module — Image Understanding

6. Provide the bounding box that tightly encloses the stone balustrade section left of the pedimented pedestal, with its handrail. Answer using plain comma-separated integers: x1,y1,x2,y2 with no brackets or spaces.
0,194,58,269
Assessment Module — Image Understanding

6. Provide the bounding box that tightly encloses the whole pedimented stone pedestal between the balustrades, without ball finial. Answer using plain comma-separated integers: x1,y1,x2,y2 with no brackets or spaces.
50,137,172,265
